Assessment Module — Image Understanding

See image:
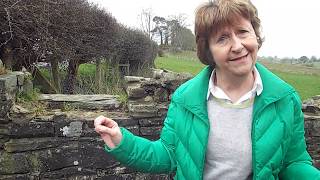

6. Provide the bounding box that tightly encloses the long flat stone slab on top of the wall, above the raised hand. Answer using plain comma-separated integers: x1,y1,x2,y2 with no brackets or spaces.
39,94,121,110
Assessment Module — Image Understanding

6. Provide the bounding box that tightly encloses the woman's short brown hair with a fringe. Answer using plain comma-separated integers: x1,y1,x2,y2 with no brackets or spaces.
195,0,263,66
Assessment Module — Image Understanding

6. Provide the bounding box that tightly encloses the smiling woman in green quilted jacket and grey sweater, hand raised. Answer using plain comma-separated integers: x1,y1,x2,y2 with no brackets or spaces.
95,0,320,180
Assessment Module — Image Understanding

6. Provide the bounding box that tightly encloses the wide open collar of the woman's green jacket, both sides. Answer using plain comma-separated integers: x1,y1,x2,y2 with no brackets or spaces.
172,63,294,121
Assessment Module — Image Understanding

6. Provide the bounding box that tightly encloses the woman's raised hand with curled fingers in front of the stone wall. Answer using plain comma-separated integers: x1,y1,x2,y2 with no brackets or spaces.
94,116,122,148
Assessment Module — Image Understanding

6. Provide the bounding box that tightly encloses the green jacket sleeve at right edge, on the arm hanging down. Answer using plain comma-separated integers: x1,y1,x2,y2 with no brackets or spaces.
279,93,320,180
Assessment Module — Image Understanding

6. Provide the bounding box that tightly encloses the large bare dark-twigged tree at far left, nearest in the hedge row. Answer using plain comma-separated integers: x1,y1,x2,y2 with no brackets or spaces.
0,0,118,93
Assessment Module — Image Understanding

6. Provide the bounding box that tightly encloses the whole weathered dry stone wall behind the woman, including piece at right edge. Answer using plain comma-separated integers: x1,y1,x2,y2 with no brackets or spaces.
0,70,320,179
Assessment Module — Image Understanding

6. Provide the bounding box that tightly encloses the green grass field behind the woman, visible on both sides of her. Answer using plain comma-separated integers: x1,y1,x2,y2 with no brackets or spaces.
155,52,320,100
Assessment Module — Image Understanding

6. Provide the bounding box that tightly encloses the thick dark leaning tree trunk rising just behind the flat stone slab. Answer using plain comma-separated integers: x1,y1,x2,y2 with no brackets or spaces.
63,60,79,94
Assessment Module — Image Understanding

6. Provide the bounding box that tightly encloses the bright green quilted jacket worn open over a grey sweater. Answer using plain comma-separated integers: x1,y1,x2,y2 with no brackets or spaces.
105,63,320,180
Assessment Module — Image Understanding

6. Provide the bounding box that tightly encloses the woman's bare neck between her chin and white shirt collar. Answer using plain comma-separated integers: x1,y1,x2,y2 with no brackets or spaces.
214,69,255,102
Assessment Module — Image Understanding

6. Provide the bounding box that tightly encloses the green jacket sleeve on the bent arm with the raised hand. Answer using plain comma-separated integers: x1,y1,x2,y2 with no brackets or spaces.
104,103,176,173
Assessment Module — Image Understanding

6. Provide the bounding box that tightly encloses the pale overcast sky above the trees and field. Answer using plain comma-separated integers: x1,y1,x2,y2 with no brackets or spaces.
89,0,320,58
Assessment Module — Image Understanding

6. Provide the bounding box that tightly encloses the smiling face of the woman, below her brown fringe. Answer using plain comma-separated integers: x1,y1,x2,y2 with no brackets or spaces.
209,17,258,76
